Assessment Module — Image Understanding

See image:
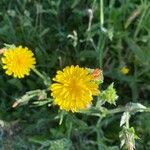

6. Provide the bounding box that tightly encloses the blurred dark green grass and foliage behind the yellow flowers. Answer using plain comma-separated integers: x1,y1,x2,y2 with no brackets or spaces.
0,0,150,150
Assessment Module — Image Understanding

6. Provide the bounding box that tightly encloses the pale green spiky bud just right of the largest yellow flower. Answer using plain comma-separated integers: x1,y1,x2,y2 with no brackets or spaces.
100,83,118,105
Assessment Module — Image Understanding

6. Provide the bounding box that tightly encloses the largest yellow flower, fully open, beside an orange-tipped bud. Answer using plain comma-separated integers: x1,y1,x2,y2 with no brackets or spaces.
50,66,99,112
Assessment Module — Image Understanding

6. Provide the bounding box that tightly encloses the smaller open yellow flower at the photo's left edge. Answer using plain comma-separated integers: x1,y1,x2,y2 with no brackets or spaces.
2,46,36,78
